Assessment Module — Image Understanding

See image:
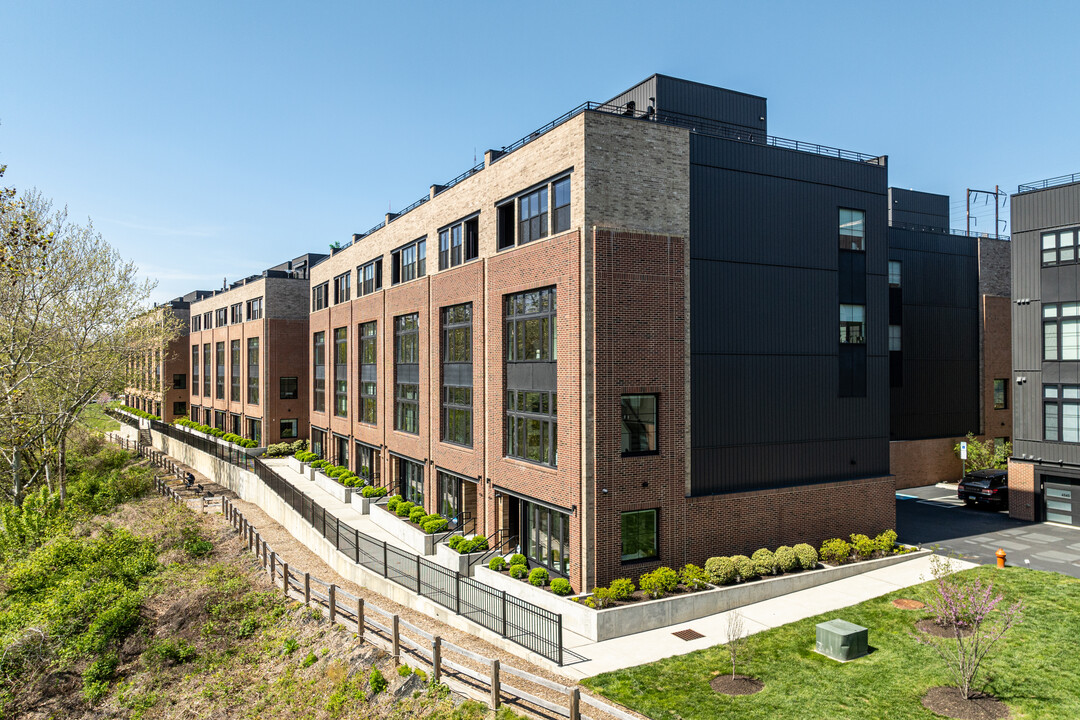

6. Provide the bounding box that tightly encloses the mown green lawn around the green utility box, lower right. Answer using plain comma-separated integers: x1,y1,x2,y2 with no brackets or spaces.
583,568,1080,720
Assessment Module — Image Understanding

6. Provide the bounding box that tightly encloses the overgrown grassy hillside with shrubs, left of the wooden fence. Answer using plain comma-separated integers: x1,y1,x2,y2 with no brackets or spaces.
0,436,516,720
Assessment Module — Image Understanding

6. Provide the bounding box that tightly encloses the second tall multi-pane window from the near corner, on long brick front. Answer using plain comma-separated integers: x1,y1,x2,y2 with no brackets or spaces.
442,302,472,447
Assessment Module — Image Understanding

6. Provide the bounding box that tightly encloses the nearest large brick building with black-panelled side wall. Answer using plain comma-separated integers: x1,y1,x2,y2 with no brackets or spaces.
306,74,902,589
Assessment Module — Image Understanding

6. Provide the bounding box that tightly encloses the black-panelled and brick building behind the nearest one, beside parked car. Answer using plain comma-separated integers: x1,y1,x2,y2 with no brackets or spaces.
889,188,1012,489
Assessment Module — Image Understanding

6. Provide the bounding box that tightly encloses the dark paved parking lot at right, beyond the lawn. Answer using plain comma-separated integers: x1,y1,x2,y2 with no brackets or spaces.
896,485,1080,578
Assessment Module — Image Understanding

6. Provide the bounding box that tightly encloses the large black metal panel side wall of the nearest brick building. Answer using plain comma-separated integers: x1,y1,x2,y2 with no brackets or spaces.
690,134,889,494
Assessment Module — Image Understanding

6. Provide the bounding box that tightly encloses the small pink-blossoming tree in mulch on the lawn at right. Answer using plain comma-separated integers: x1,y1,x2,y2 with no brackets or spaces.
915,556,1024,698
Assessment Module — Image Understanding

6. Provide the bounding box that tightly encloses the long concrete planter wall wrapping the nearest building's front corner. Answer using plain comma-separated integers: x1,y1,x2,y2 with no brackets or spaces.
474,549,931,642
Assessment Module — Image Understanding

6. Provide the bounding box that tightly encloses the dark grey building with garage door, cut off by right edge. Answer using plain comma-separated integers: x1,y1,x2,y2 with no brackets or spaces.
1009,174,1080,526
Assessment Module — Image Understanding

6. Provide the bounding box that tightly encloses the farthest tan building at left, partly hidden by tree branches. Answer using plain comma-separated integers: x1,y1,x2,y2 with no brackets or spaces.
124,290,210,422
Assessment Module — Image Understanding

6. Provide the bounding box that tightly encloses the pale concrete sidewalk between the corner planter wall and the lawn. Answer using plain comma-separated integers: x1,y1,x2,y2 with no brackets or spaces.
559,555,976,680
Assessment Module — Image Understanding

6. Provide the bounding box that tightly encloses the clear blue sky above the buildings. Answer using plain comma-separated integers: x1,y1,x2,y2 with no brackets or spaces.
0,0,1080,300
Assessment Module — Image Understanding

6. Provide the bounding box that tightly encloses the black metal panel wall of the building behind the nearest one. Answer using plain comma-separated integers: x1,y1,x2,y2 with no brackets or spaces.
889,226,981,440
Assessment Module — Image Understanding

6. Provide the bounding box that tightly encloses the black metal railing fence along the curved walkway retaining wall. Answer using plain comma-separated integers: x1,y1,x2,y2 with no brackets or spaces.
139,420,563,665
